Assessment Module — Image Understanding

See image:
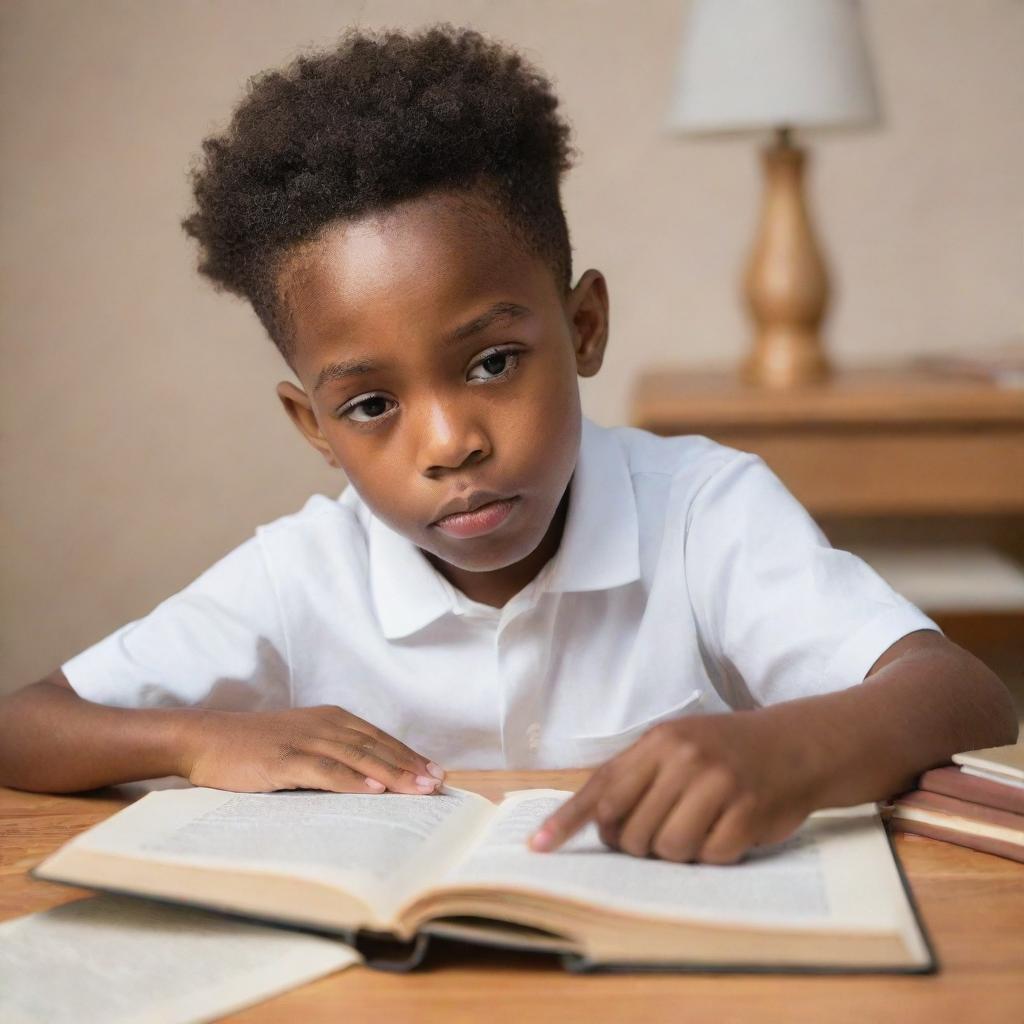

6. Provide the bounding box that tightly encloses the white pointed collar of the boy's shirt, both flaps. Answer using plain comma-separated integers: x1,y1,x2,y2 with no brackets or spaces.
369,417,640,640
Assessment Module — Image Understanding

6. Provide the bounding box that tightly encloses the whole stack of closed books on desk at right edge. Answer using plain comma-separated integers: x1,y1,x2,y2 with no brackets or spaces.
890,743,1024,863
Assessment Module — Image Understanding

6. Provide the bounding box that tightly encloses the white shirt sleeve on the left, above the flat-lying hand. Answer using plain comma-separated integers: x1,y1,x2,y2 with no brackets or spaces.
60,534,291,710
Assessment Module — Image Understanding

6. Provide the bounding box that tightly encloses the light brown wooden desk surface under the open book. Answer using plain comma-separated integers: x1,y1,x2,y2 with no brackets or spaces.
0,772,1024,1024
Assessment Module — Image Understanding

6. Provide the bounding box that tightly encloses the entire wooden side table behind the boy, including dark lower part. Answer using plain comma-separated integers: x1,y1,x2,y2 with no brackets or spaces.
631,367,1024,715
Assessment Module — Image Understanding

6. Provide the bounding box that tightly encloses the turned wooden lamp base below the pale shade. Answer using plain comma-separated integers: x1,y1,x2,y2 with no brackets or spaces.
740,128,831,388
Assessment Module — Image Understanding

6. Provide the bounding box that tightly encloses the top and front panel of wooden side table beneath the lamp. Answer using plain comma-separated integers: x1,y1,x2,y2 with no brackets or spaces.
632,368,1024,522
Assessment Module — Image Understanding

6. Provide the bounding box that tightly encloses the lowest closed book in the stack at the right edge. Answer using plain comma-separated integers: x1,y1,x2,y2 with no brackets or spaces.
890,790,1024,863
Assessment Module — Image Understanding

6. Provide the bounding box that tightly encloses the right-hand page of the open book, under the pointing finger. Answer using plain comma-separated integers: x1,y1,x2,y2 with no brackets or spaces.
443,790,916,931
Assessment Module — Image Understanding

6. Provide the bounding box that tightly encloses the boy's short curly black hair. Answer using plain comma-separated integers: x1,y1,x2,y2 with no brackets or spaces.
181,24,575,364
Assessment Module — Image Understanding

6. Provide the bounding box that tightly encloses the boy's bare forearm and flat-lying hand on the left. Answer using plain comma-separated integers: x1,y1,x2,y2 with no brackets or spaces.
0,669,443,794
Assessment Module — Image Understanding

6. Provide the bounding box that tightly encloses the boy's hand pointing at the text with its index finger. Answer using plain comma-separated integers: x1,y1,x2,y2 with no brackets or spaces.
529,711,815,864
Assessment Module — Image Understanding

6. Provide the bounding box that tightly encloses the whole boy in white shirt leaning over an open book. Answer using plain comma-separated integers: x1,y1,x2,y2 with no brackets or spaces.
0,27,1017,863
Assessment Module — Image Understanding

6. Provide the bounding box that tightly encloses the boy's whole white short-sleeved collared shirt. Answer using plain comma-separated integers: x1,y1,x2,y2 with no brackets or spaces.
61,419,938,769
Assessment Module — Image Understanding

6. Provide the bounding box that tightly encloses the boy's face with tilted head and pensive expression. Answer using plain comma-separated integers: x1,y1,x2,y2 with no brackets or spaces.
278,194,607,603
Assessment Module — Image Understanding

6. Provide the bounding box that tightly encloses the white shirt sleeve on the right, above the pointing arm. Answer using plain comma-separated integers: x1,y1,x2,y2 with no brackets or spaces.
684,453,941,707
